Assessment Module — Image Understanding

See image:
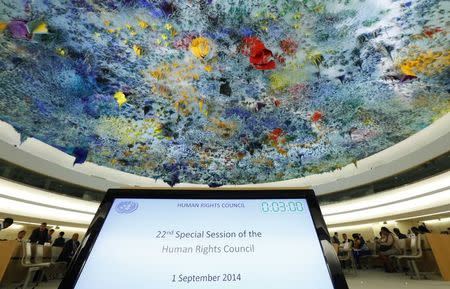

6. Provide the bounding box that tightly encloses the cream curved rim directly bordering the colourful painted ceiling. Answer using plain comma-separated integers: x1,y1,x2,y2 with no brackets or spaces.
0,113,450,195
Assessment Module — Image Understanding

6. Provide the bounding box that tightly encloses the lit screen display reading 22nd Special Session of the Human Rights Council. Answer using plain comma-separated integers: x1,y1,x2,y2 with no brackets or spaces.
69,191,341,289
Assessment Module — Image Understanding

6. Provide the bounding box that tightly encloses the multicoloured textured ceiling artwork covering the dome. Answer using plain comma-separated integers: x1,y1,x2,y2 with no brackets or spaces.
0,0,450,186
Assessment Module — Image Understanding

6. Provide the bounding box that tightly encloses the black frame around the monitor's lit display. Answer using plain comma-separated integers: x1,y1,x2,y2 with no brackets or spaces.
58,189,348,289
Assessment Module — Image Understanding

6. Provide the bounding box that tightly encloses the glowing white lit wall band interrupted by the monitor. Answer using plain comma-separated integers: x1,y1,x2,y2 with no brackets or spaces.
0,171,450,227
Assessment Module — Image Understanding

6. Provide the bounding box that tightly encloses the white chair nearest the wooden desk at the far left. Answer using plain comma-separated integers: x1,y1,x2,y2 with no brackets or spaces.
16,242,50,289
